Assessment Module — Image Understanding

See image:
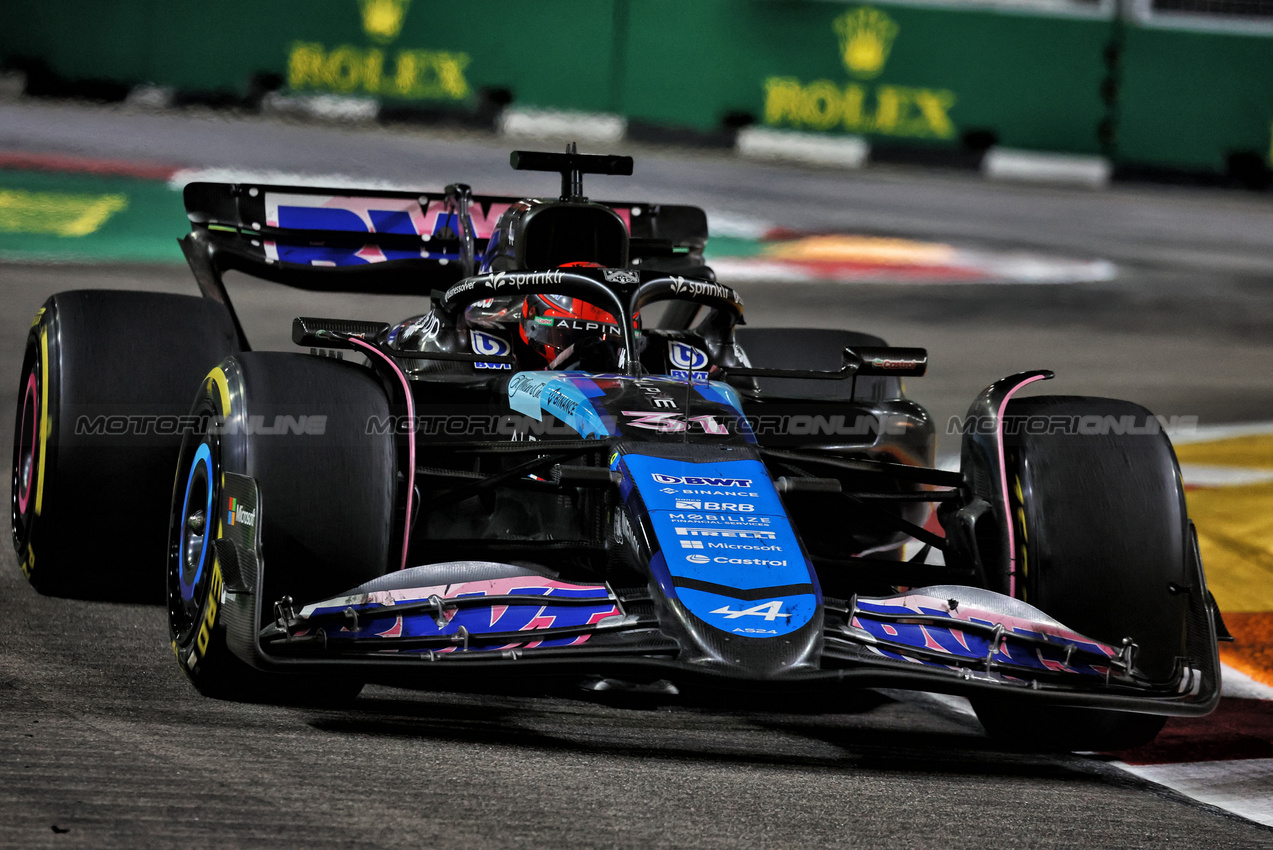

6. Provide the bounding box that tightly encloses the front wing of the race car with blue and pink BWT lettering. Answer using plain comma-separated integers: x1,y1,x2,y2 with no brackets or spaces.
215,475,1220,715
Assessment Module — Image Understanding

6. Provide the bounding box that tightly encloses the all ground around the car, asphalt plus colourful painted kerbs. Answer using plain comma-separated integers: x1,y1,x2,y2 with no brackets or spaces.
0,103,1273,847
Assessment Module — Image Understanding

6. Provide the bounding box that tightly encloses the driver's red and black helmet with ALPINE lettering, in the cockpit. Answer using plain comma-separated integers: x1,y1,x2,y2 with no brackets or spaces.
521,262,640,372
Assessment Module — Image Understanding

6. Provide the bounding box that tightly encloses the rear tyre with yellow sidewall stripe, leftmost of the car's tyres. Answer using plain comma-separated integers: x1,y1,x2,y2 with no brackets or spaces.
11,290,238,601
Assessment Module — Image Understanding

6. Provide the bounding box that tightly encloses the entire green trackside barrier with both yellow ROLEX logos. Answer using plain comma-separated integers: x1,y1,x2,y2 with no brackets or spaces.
0,0,1273,172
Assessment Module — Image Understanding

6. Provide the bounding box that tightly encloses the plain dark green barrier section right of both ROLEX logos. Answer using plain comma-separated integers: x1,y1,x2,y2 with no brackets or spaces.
1116,25,1273,173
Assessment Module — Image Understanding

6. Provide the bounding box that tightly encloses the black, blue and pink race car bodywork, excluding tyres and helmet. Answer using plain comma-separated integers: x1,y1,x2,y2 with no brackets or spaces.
164,151,1218,714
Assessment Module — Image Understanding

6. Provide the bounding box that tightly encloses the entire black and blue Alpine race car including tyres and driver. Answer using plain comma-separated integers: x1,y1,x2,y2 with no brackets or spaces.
13,146,1223,748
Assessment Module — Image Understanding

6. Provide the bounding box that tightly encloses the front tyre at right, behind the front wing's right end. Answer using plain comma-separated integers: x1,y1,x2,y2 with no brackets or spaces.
974,396,1192,749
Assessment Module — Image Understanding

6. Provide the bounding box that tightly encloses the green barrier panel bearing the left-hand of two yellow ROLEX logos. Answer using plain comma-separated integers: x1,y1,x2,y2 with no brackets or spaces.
0,0,622,111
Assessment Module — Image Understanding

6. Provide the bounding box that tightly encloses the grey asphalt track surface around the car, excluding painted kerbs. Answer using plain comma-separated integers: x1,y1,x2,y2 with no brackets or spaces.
0,104,1273,847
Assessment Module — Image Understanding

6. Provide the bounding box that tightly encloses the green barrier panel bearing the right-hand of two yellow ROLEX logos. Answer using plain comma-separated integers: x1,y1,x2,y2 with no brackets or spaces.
624,0,1111,153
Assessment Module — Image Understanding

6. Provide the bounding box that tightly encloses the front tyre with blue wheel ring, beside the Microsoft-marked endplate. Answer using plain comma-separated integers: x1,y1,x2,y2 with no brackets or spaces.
168,352,397,702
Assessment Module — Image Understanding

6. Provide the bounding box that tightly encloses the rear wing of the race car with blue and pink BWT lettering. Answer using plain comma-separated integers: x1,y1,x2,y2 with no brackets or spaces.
181,183,708,300
